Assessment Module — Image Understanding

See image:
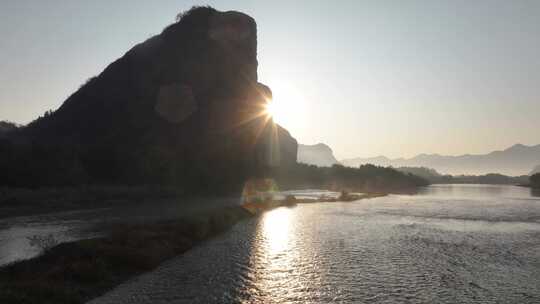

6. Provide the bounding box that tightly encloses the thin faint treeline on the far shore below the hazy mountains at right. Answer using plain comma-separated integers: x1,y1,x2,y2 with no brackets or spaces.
397,167,529,185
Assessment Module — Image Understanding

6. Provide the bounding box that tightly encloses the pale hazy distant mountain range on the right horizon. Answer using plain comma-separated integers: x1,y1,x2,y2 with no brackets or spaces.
341,144,540,176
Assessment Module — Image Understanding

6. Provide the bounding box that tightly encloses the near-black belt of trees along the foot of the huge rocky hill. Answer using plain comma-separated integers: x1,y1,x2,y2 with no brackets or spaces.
0,138,253,194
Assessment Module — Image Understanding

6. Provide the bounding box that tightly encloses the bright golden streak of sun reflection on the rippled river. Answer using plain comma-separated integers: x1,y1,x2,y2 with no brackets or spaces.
242,207,324,303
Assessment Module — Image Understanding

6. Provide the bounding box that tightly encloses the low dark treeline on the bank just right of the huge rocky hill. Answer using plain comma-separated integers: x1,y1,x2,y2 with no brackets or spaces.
272,164,429,193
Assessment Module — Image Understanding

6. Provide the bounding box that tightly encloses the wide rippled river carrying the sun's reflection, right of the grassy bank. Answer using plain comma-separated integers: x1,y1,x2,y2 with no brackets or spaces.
93,185,540,303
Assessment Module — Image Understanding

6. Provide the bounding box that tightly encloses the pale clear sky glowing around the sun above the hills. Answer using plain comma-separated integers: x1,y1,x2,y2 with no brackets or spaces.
0,0,540,159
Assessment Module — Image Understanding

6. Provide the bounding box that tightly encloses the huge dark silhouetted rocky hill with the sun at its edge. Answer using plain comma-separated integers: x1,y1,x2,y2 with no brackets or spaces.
0,7,297,192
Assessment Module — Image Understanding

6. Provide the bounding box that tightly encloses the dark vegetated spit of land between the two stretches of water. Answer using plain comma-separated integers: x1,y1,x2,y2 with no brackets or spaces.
0,207,250,304
